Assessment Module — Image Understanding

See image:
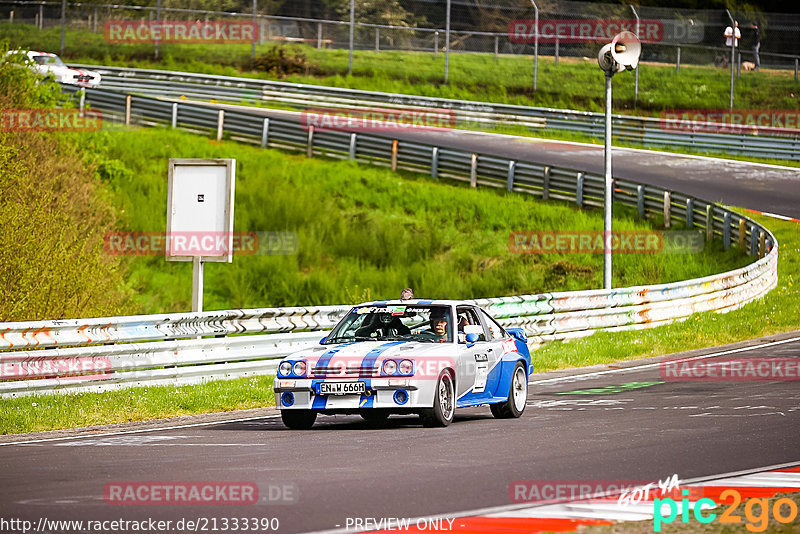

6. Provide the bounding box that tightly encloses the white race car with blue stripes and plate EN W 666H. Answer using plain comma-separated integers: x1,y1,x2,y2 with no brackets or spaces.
274,300,533,429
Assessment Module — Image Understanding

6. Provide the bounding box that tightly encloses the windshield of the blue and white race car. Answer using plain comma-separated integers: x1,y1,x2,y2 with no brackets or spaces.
325,305,453,345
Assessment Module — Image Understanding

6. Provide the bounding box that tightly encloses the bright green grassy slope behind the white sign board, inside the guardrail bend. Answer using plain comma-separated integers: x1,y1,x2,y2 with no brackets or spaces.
67,127,752,313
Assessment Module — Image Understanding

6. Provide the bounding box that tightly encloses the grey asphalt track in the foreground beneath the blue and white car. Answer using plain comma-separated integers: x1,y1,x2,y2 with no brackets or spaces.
0,331,800,532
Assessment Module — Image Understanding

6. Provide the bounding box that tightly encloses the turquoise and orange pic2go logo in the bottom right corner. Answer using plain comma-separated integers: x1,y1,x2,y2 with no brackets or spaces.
653,489,797,532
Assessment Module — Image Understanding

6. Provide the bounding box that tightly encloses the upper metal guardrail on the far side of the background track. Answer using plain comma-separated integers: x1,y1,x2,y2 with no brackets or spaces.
76,65,800,161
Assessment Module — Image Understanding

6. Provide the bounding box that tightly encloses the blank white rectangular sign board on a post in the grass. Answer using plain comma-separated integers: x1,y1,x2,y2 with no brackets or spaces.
167,159,236,263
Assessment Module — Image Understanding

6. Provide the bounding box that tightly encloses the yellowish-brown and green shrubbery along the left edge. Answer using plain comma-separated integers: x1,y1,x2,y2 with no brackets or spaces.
0,42,127,321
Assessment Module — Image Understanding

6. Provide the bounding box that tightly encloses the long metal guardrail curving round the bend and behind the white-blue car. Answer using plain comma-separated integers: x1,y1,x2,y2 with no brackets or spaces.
0,86,778,396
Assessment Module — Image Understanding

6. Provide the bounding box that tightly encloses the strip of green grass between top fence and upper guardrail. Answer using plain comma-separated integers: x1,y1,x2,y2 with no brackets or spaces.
0,23,800,115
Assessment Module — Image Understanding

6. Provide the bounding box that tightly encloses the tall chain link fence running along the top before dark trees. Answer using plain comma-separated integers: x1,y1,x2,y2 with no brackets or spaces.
0,0,800,81
